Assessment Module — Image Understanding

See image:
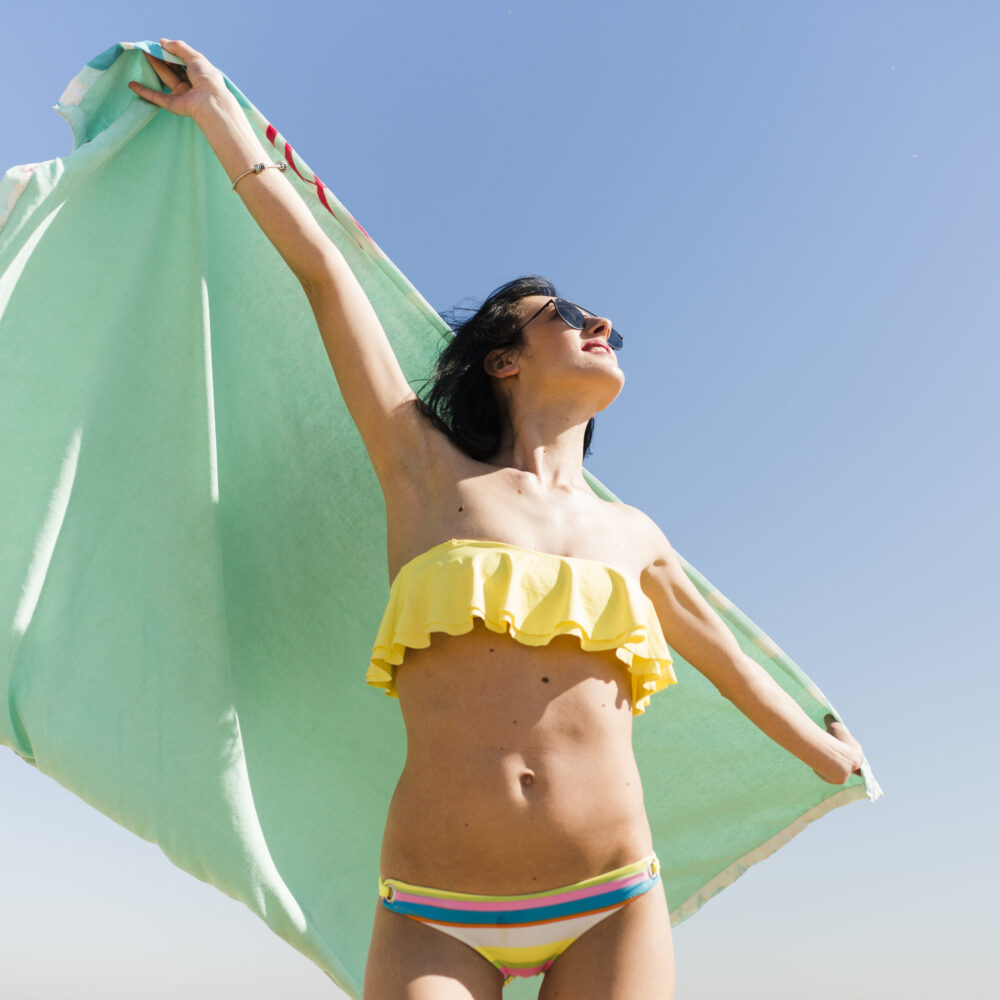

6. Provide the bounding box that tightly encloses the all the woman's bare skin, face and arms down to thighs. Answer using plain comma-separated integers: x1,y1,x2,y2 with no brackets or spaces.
130,42,862,1000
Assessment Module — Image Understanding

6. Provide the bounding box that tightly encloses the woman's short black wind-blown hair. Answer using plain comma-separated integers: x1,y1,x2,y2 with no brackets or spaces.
417,274,594,461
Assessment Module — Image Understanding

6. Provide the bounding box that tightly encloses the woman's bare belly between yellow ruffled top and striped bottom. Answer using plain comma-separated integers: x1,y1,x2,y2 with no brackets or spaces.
382,623,651,894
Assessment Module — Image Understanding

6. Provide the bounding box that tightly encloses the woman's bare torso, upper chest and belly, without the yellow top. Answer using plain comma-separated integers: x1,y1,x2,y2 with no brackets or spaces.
381,443,651,894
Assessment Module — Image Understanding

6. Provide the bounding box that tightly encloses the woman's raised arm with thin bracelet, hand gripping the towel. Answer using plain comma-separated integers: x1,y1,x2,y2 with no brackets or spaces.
129,39,437,487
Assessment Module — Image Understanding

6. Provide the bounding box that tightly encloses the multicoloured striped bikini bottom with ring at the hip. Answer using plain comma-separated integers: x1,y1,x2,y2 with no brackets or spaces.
378,854,660,983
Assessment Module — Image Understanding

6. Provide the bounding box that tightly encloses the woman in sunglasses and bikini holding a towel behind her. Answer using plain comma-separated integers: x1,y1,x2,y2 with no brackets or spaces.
130,41,863,1000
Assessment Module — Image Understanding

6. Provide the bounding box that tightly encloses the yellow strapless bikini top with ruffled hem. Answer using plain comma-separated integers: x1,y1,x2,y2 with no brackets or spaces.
365,538,677,715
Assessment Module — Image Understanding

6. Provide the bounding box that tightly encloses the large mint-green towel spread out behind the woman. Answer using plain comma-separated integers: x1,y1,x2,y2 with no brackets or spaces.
0,42,878,996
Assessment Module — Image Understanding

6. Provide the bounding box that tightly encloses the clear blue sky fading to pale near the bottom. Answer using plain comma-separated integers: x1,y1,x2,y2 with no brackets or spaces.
0,0,1000,1000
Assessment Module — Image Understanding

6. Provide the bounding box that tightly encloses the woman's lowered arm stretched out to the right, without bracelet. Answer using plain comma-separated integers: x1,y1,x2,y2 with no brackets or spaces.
642,515,864,785
